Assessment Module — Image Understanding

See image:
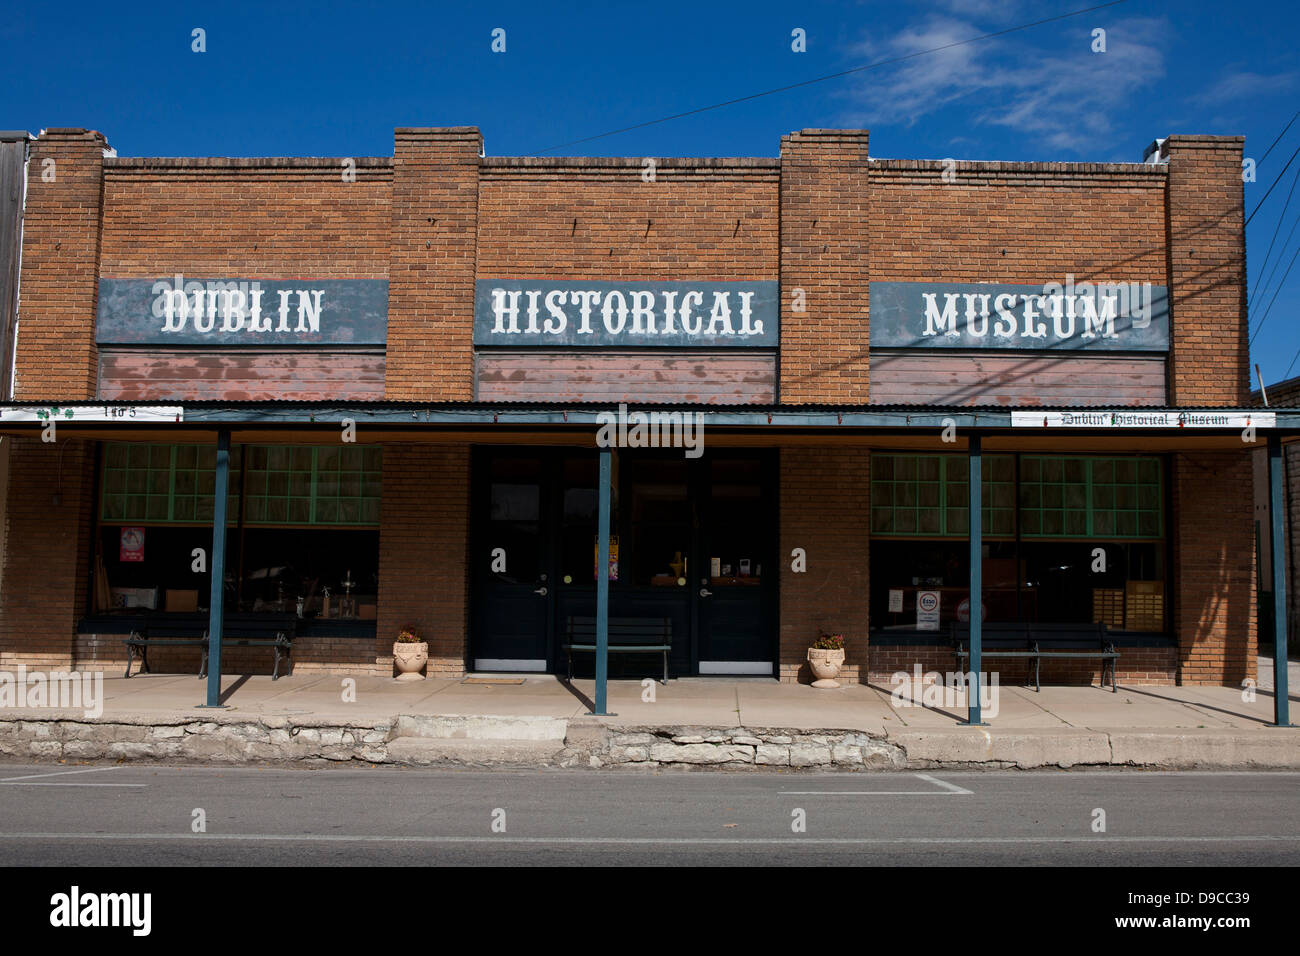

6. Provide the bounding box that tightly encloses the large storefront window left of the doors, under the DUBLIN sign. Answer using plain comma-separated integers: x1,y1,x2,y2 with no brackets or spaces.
90,442,382,622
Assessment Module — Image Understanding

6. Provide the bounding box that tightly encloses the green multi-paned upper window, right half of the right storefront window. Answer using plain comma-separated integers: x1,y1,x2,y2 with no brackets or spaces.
1021,455,1164,538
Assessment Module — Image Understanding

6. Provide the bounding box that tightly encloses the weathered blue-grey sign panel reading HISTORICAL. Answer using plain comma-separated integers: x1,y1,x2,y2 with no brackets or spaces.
475,278,780,349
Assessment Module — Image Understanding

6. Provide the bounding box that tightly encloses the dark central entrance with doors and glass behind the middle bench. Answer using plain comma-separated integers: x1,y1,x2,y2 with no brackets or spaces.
469,447,777,678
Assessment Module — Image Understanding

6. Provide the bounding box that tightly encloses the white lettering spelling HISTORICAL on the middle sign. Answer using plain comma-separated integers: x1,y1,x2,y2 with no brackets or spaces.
488,287,769,338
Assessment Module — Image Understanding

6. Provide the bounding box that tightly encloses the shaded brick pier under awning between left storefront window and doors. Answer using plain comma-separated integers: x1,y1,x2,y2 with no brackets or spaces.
376,445,469,676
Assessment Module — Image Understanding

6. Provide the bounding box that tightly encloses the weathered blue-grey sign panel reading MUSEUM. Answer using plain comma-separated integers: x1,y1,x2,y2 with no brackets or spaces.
871,276,1169,352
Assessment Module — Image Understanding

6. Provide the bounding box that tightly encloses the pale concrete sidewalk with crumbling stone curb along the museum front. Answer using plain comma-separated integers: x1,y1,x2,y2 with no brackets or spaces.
0,675,1300,769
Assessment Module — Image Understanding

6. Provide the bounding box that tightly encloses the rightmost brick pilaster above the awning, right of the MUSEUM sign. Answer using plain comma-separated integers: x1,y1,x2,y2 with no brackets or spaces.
1164,137,1251,406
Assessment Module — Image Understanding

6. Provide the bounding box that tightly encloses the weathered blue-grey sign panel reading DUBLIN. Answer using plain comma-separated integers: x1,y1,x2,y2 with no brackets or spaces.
95,276,389,347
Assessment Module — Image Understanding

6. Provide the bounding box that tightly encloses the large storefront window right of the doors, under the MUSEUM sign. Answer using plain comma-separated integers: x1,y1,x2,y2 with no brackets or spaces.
871,454,1166,632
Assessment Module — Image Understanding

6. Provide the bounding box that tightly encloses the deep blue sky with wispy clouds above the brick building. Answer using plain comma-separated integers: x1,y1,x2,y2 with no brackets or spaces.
0,0,1300,382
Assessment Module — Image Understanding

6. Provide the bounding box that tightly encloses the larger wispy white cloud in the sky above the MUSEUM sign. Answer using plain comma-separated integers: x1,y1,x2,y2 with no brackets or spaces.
846,13,1169,155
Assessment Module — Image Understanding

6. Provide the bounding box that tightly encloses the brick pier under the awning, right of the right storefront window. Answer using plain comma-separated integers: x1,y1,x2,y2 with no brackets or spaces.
1169,451,1256,685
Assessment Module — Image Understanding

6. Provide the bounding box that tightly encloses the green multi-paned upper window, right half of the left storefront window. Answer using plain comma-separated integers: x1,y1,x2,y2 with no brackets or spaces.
244,445,384,525
